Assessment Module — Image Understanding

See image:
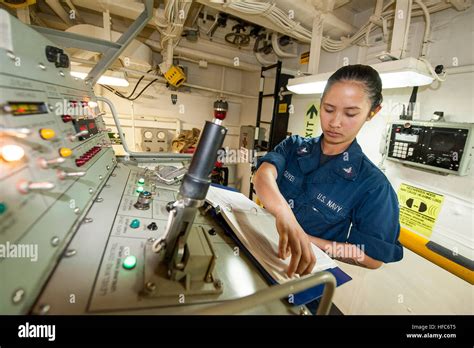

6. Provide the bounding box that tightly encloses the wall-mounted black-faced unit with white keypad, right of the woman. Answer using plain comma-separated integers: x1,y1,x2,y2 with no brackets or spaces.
387,121,474,175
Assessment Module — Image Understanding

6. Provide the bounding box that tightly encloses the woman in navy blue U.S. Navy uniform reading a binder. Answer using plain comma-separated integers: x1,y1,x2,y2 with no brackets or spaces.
253,65,403,276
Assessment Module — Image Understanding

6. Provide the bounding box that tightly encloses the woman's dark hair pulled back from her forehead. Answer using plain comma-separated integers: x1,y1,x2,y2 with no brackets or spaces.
321,64,383,110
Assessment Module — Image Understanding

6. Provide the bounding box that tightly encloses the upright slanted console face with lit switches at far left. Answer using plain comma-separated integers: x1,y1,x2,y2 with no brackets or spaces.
0,10,116,314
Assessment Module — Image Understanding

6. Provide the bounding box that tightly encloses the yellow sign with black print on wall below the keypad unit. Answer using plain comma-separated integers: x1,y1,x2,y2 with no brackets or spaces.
398,184,444,238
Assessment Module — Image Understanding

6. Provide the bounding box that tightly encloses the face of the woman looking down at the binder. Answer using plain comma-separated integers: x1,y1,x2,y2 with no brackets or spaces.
320,81,371,144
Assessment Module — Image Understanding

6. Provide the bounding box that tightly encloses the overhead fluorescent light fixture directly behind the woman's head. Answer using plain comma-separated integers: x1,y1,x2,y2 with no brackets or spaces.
287,57,434,94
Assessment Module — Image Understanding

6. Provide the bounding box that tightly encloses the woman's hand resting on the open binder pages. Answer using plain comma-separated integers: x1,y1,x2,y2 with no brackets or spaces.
276,210,316,277
